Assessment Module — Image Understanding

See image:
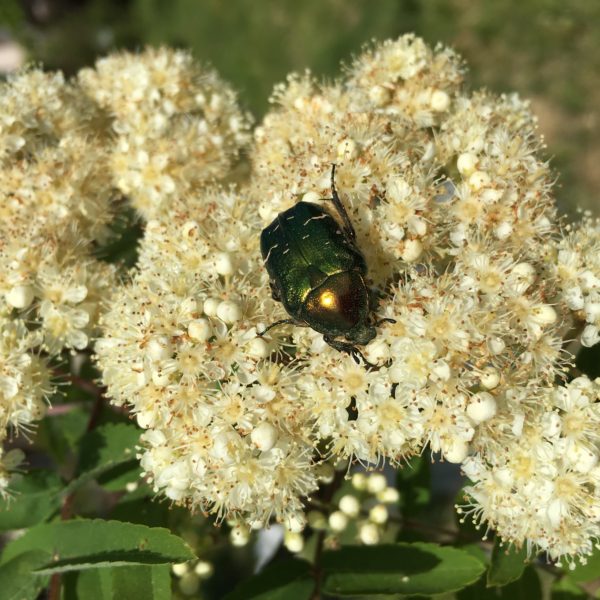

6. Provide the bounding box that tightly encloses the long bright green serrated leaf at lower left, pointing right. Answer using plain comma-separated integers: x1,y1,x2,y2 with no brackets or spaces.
2,519,195,574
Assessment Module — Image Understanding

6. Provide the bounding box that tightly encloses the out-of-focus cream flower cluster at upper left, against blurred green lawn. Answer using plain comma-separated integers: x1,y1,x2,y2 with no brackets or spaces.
78,48,250,219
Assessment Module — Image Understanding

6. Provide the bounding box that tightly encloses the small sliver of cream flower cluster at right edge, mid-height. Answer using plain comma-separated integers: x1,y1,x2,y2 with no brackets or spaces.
554,216,600,346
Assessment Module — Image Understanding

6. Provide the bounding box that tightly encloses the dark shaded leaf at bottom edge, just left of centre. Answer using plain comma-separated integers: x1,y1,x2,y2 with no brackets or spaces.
225,559,315,600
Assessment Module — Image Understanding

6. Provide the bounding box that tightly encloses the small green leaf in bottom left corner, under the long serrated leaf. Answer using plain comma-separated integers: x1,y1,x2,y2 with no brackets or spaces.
0,550,51,600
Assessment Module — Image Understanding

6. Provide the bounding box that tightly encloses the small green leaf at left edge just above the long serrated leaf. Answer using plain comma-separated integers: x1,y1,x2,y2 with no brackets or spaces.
0,470,62,531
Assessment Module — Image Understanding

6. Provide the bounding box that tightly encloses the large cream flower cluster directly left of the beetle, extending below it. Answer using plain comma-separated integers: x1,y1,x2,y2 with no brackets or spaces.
96,189,318,522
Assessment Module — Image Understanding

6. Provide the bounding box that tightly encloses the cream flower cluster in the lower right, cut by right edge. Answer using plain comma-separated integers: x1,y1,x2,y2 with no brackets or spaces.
459,377,600,564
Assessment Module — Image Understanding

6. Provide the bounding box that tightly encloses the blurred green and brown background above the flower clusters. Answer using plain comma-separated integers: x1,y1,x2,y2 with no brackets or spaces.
0,0,600,214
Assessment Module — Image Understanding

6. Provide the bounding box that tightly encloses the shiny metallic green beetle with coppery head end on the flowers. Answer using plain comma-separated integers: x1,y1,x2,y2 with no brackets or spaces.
260,165,387,362
